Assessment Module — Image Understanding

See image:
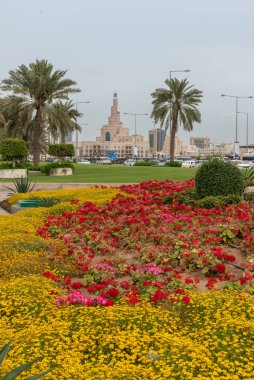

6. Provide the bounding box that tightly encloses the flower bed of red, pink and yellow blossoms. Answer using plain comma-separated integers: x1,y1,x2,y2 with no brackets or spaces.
0,180,254,380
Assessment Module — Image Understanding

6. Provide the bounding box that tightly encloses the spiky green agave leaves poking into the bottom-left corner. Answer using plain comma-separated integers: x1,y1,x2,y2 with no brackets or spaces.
0,340,50,380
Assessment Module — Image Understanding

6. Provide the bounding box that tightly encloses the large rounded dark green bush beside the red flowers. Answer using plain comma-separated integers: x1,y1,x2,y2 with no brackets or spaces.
195,159,243,198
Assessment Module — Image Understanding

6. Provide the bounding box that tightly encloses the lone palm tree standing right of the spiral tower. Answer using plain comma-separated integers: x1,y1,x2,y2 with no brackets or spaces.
151,78,202,161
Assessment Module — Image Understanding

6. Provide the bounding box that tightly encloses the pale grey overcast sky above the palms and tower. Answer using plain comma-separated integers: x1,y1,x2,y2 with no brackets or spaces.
0,0,254,145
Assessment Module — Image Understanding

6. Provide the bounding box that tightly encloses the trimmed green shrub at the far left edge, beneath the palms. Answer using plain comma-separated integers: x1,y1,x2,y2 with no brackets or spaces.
0,138,29,167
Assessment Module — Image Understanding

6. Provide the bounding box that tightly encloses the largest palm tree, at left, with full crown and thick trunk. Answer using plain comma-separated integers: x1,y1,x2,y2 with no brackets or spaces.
1,60,80,167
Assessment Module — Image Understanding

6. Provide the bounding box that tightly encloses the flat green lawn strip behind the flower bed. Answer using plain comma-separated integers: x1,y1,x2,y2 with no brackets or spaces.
19,165,196,183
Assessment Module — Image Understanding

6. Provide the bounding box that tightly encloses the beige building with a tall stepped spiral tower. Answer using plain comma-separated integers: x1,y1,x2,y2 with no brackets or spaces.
78,93,149,158
